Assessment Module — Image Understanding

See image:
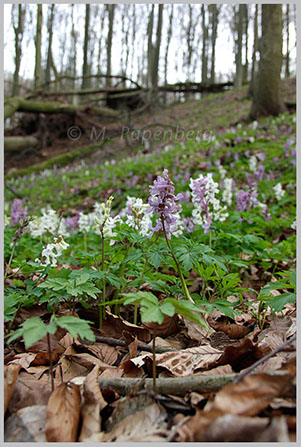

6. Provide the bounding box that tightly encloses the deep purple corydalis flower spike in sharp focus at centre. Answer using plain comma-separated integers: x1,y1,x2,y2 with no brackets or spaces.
147,169,183,239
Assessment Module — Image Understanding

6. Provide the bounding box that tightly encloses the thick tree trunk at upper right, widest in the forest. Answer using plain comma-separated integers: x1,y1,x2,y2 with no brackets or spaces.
251,4,284,118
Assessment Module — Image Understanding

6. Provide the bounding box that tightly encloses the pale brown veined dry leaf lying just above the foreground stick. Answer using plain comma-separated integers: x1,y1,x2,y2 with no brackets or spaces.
131,345,222,377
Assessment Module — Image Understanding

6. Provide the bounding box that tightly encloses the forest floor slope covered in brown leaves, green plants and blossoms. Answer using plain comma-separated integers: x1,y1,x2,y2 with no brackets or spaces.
4,80,296,443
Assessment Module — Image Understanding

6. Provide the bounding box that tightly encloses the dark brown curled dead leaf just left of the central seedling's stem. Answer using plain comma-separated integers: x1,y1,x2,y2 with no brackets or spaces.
101,312,152,343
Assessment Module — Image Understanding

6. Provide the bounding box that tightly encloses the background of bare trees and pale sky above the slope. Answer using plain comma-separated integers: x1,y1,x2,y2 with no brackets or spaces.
5,4,296,170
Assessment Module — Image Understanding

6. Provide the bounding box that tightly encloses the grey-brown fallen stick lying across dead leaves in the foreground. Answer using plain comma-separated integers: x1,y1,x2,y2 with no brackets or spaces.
98,371,295,396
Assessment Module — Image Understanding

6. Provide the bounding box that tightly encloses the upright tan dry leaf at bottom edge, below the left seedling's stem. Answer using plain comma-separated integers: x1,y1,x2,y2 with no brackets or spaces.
45,383,81,442
